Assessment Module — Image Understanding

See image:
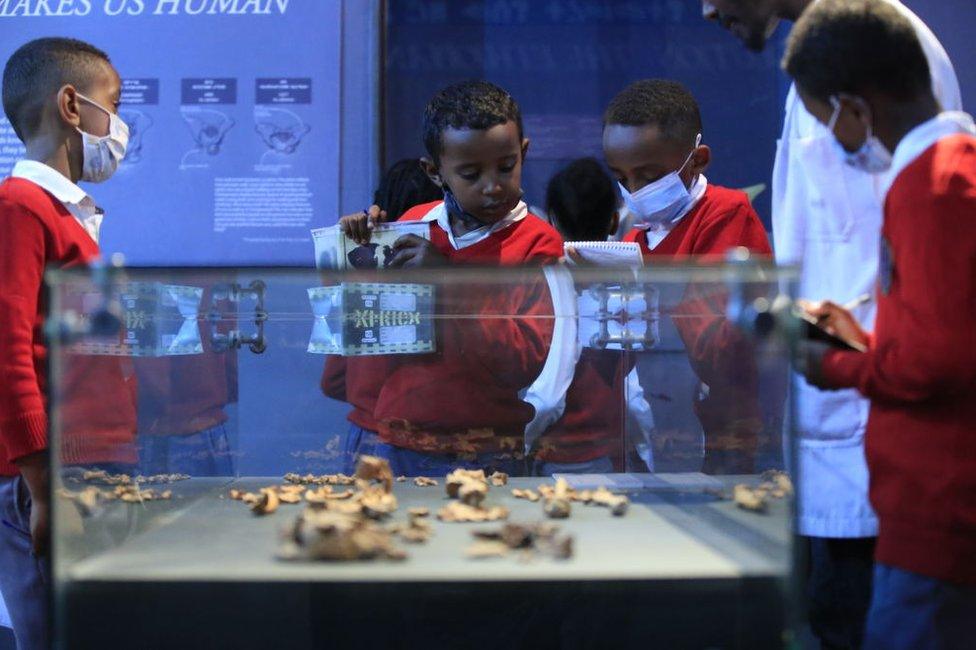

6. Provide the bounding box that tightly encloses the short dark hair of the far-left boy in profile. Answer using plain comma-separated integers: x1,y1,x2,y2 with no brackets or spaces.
3,38,111,140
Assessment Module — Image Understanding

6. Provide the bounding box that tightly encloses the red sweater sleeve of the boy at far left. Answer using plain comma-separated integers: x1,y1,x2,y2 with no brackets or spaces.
0,200,47,462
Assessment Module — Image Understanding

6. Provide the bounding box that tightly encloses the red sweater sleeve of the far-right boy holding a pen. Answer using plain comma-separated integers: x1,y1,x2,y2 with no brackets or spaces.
822,168,976,402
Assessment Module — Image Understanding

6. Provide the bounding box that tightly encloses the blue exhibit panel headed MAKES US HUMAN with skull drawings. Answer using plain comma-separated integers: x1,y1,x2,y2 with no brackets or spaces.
0,0,342,266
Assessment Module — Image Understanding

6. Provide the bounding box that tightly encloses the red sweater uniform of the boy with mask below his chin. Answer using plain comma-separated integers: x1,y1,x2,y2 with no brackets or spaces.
333,201,562,475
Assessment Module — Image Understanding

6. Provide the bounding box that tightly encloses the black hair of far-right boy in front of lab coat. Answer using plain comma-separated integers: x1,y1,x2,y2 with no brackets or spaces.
783,0,932,102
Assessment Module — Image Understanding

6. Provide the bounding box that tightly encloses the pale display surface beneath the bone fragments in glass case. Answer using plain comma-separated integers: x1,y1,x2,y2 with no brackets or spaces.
59,474,791,583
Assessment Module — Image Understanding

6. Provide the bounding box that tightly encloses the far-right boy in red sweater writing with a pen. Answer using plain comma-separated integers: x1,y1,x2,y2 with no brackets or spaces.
783,0,976,648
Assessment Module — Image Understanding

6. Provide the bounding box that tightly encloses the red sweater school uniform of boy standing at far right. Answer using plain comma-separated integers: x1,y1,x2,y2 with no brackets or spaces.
822,113,976,648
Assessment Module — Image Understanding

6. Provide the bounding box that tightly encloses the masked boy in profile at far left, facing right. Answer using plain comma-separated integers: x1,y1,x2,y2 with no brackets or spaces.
0,38,135,648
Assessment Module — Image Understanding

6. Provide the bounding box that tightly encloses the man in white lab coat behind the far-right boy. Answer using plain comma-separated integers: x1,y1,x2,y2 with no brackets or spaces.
703,0,962,648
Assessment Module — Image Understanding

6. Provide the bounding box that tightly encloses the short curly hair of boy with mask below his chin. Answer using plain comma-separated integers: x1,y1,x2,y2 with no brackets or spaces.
424,80,523,163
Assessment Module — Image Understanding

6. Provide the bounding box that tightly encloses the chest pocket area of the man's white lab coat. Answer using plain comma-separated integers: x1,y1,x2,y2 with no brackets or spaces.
787,136,854,242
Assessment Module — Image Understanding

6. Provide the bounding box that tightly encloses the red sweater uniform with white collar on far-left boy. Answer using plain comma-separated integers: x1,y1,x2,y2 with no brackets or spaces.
0,161,135,648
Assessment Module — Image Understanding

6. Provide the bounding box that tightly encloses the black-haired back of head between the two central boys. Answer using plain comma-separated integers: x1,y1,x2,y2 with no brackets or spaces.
546,158,617,241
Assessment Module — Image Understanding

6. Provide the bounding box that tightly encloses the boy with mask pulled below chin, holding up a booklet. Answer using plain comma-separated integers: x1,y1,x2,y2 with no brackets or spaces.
324,81,562,475
